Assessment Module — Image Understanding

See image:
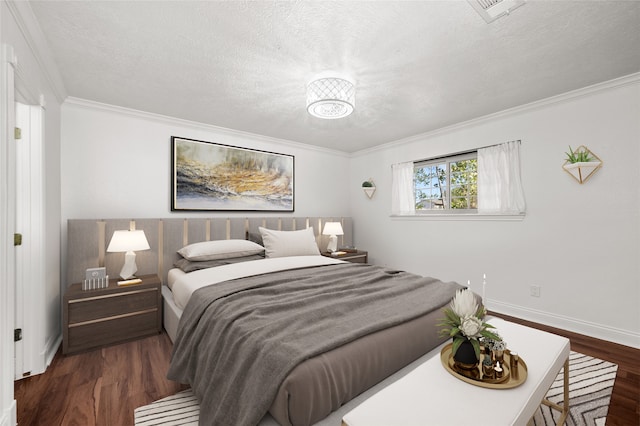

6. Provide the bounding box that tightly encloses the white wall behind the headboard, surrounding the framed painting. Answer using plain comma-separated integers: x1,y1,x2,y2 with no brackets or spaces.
62,99,349,222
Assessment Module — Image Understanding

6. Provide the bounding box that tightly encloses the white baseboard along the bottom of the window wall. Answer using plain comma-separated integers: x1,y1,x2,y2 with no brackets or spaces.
487,300,640,349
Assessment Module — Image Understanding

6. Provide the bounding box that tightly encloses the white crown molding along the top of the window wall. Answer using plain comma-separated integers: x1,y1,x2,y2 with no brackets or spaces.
351,72,640,157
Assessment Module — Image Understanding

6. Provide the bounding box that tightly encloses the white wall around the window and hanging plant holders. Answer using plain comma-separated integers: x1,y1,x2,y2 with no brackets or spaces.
350,75,640,347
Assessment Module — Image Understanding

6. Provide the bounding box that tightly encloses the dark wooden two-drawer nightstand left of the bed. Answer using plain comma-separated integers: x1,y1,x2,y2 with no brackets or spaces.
62,275,162,354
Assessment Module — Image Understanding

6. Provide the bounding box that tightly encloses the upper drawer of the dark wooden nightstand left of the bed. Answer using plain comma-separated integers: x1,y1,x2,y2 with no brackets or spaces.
68,288,158,325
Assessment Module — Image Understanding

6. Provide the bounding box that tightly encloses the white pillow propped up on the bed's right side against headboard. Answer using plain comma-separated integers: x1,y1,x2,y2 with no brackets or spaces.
258,226,320,257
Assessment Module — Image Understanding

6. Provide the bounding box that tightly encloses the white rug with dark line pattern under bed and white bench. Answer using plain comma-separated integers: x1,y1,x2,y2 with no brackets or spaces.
134,352,618,426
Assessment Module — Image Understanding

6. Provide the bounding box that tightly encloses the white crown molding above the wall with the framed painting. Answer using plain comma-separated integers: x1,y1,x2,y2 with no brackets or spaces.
64,96,350,158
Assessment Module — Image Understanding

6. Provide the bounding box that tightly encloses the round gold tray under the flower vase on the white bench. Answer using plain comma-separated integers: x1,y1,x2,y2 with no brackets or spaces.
440,343,528,389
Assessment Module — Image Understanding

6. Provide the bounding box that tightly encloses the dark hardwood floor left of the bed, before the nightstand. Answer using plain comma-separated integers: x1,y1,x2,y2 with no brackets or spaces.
14,333,185,426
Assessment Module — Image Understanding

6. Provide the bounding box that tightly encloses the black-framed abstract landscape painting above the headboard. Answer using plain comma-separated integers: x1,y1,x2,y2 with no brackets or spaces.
171,136,294,212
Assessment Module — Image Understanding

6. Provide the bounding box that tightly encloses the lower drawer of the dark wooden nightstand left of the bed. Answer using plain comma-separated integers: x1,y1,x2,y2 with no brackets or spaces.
67,309,158,352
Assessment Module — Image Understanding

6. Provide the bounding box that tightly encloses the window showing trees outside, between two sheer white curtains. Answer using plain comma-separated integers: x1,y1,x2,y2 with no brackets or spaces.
413,151,478,214
